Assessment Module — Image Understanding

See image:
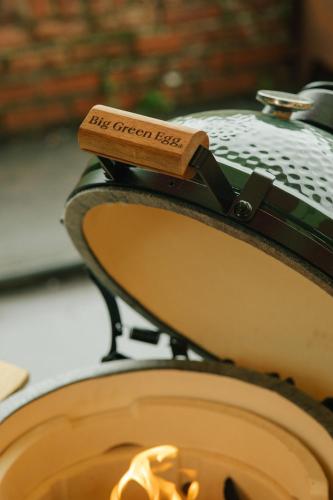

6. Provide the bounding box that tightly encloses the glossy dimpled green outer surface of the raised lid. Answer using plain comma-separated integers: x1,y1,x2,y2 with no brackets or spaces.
176,111,333,215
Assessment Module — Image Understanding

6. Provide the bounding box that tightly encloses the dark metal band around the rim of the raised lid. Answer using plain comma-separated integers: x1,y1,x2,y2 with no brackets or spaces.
78,160,333,280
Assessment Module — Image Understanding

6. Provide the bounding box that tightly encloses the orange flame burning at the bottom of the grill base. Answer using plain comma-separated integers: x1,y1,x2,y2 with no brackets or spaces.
110,445,199,500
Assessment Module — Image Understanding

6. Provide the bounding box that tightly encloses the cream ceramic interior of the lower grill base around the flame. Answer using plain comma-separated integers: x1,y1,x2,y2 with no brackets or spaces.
0,370,333,500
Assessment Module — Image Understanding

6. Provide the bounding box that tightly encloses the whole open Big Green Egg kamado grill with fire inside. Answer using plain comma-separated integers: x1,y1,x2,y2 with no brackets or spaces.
0,83,333,500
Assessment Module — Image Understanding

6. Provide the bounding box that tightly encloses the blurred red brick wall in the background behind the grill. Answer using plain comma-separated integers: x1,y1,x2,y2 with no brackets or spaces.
0,0,293,133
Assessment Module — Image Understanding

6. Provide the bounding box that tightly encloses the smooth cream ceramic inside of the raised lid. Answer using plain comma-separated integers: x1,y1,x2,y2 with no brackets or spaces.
81,201,333,398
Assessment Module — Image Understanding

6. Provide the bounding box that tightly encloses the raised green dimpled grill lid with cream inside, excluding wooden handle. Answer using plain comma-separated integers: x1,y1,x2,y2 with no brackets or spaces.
65,84,333,398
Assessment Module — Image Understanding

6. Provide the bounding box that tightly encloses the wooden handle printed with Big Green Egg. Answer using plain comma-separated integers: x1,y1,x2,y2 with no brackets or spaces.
78,105,209,176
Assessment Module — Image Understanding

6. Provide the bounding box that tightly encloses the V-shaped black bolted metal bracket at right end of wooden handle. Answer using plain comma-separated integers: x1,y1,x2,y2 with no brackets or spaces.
189,146,275,222
